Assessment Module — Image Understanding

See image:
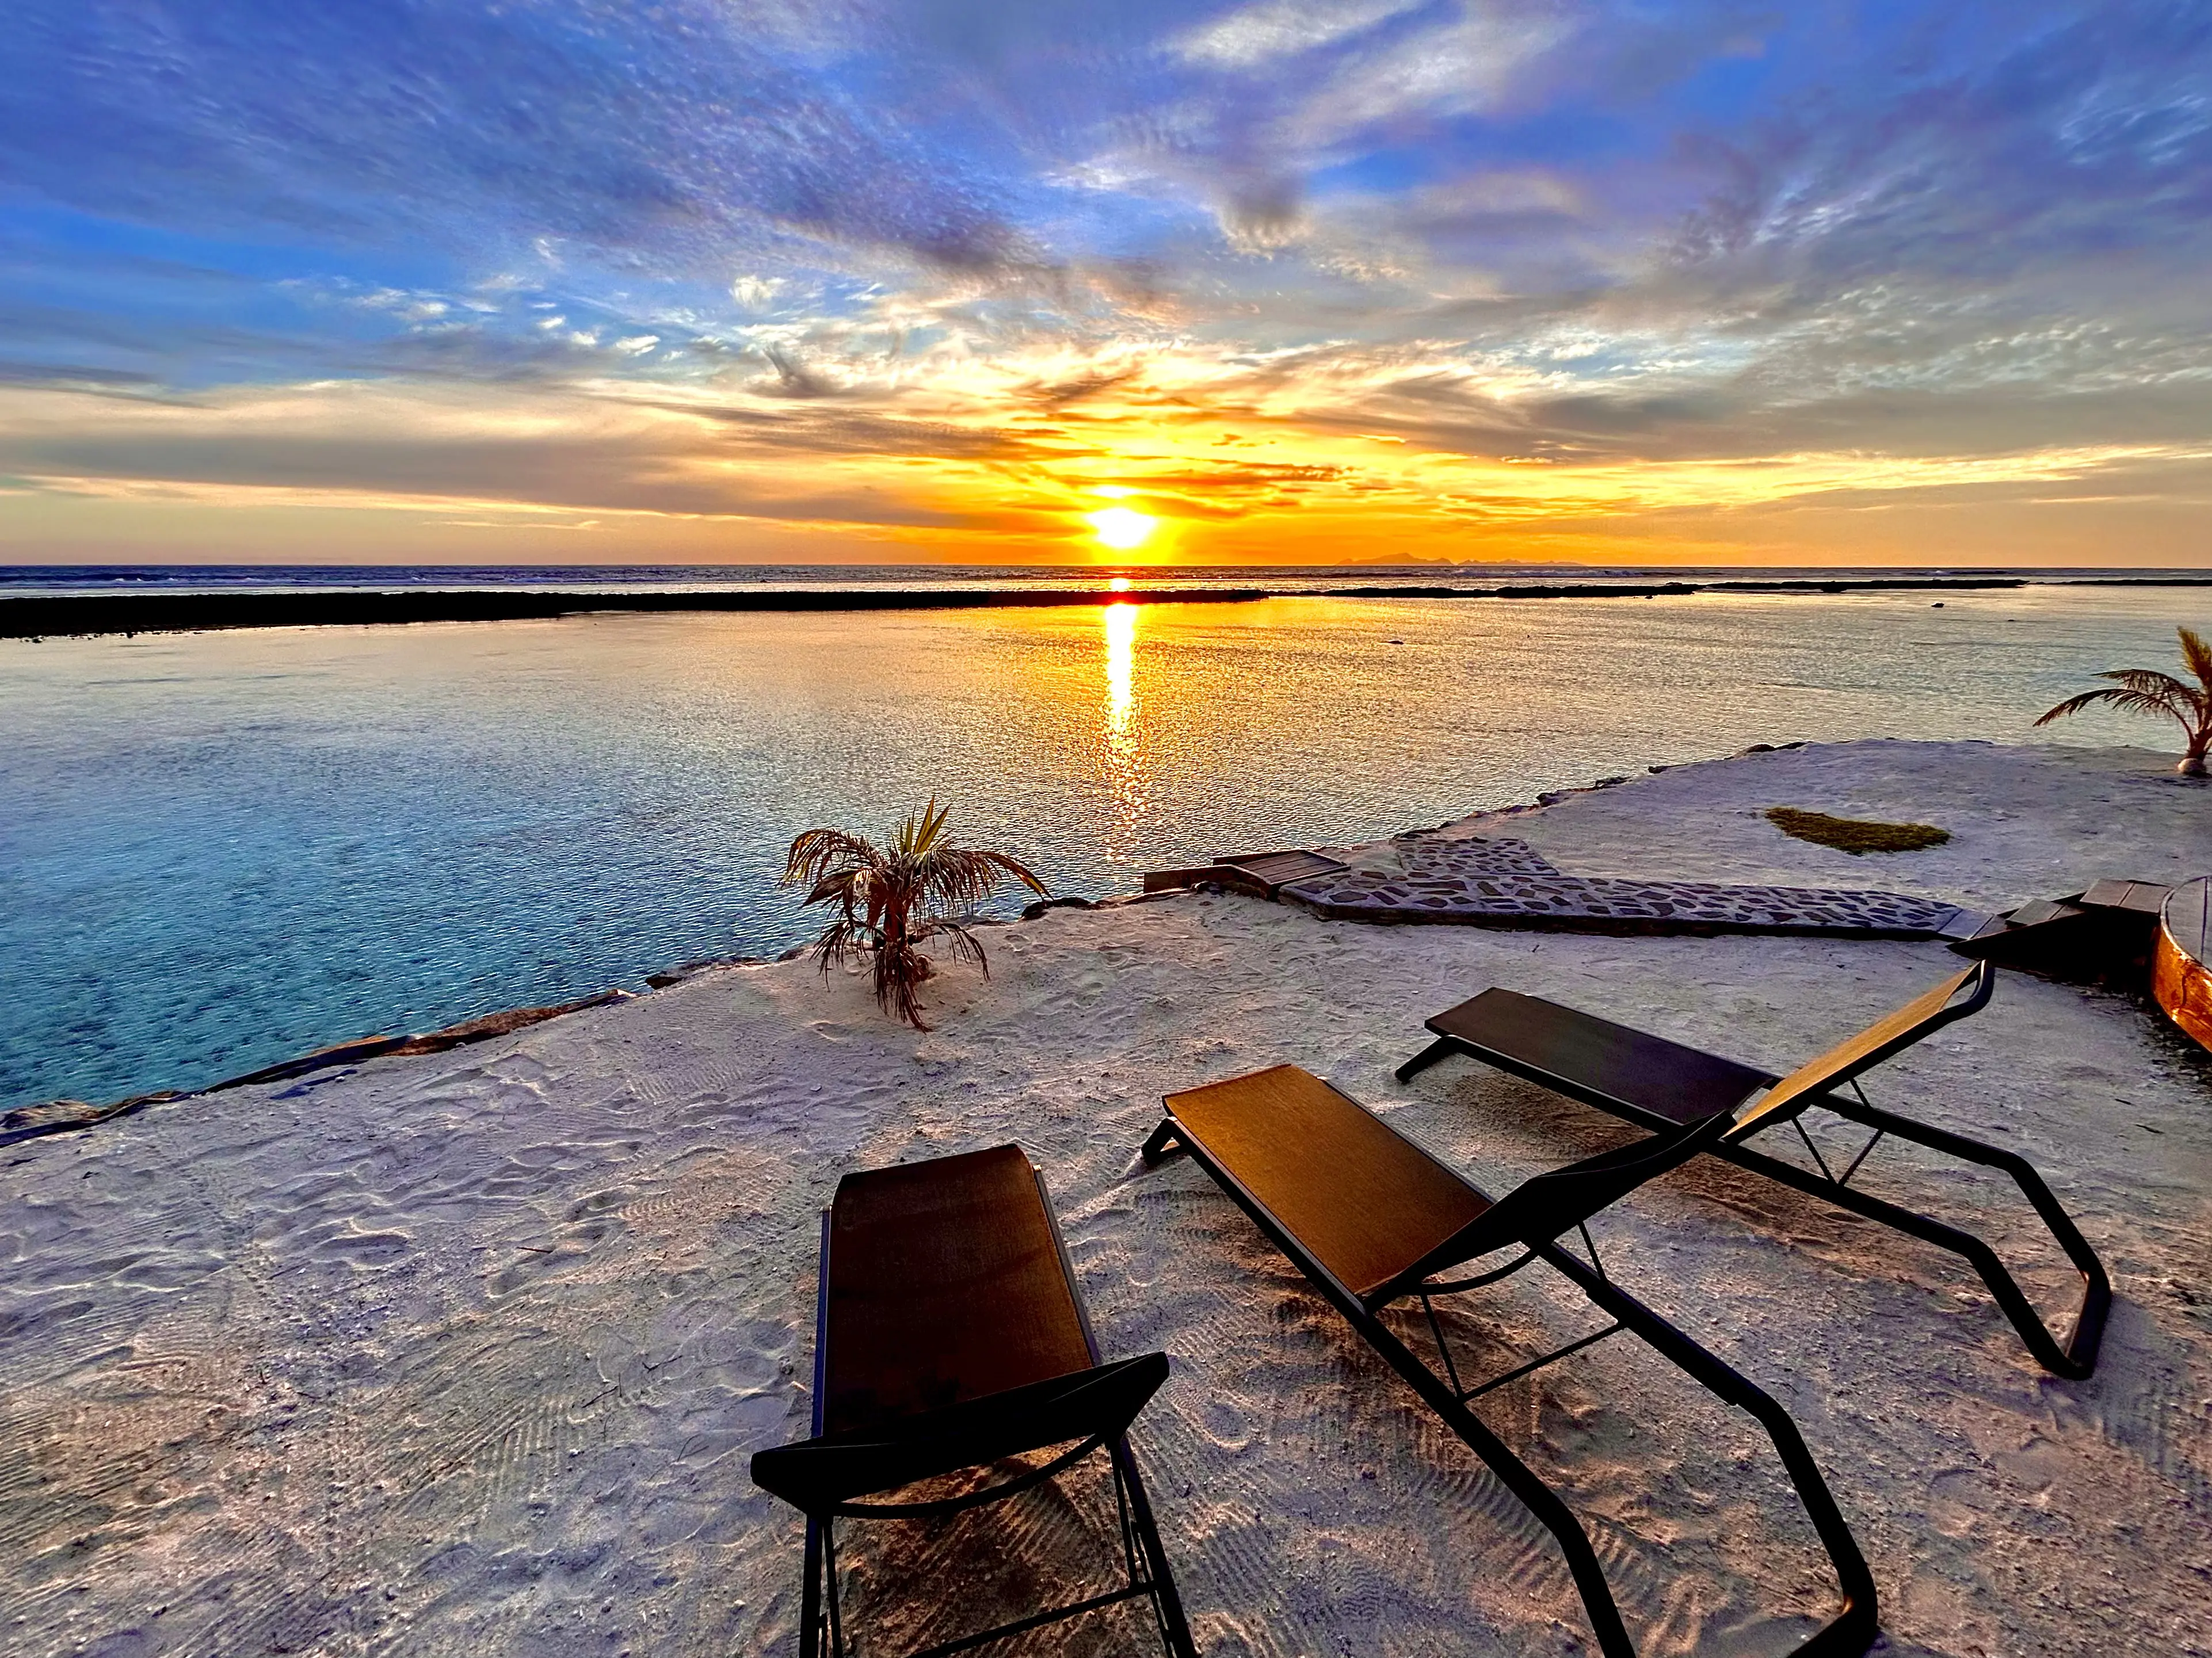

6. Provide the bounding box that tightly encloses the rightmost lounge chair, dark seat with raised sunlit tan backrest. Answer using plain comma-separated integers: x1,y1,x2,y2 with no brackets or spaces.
1398,962,2112,1377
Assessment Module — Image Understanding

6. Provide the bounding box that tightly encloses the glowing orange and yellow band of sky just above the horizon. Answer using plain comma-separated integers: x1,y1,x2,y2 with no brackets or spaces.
0,365,2212,566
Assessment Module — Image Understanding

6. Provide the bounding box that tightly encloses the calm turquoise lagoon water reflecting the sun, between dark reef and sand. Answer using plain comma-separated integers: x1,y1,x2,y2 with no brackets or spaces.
0,588,2212,1107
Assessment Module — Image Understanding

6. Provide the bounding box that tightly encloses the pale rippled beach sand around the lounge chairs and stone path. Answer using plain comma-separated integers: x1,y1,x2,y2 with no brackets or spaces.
0,743,2212,1656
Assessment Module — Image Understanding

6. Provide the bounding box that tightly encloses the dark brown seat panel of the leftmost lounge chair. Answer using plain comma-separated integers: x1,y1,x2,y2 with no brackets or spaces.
816,1145,1097,1435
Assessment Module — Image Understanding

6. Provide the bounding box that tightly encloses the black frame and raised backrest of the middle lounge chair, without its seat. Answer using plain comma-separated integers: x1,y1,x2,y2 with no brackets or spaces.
1142,1068,1878,1658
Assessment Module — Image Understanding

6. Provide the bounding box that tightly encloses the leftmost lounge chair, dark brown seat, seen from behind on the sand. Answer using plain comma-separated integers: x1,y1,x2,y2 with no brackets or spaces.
752,1145,1195,1658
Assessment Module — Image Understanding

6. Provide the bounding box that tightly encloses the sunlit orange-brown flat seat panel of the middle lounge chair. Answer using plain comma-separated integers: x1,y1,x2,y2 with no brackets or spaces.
1168,1065,1491,1296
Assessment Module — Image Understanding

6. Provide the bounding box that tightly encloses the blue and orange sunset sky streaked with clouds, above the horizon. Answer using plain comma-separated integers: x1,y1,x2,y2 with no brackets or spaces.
0,0,2212,566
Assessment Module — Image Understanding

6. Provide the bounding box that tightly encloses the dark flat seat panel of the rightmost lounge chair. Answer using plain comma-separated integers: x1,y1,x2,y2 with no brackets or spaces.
1429,988,1774,1123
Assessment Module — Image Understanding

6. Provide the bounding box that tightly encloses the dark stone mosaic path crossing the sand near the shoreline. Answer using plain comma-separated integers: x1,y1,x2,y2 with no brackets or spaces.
1281,840,1980,937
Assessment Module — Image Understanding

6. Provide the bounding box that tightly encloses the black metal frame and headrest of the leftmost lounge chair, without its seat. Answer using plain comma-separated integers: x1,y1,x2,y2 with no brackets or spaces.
752,1147,1197,1658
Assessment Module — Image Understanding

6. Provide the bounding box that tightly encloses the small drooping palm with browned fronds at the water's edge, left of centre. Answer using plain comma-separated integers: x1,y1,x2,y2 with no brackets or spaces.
783,796,1051,1030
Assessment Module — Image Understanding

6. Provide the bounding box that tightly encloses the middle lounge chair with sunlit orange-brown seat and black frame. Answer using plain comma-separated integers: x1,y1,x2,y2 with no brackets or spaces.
1143,1065,1876,1658
